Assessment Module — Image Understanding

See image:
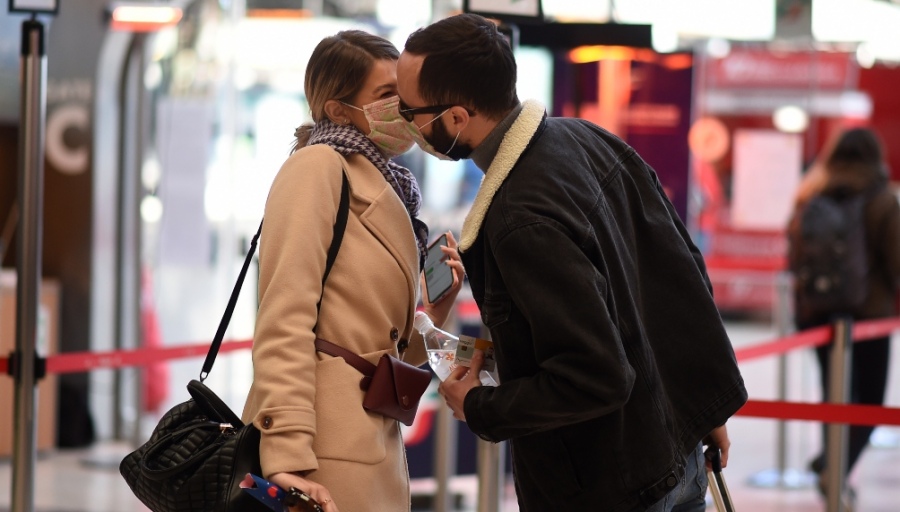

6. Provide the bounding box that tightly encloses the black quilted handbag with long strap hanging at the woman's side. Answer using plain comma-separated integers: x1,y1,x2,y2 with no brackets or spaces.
119,175,350,512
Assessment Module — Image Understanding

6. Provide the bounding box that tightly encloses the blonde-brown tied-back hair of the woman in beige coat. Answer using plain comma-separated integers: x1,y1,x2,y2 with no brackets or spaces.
291,30,400,153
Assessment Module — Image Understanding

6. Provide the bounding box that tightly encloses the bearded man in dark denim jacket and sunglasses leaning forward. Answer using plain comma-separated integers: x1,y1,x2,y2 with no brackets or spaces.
397,14,747,512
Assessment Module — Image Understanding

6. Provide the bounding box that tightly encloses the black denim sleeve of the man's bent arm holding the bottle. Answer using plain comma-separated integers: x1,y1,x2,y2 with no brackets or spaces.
464,222,635,441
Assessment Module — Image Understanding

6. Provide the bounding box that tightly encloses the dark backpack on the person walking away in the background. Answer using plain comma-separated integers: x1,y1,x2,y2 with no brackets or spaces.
789,193,871,321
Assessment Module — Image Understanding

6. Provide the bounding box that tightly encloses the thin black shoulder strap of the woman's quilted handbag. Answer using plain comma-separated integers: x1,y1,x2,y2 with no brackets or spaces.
200,170,350,382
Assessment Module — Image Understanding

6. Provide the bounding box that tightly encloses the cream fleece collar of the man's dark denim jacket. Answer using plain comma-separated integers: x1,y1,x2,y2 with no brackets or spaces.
459,100,544,252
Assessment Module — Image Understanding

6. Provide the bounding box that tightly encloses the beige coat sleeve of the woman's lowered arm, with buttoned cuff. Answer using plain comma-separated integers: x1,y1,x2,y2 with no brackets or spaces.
252,146,342,477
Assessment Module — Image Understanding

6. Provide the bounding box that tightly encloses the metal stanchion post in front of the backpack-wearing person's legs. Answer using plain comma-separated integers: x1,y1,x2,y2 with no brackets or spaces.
822,318,853,512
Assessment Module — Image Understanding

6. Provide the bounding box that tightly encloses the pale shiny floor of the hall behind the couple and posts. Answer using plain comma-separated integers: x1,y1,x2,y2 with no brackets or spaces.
0,320,900,512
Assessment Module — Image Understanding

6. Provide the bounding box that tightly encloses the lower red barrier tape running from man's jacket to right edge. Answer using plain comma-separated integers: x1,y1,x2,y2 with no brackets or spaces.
737,400,900,426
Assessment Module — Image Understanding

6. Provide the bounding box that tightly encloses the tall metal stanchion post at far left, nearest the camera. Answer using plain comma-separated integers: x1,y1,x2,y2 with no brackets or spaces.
12,16,47,512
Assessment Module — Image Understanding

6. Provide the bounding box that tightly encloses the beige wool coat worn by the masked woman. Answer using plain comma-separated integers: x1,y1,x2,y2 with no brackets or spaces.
243,145,425,512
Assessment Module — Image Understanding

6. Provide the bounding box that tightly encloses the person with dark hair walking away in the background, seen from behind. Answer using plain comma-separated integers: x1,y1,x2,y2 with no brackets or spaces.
789,128,900,502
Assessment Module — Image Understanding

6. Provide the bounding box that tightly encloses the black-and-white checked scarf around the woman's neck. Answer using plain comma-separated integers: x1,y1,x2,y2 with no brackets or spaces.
307,118,428,268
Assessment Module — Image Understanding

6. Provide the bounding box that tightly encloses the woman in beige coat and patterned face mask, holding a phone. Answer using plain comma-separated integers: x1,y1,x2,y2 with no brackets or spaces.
243,31,462,512
